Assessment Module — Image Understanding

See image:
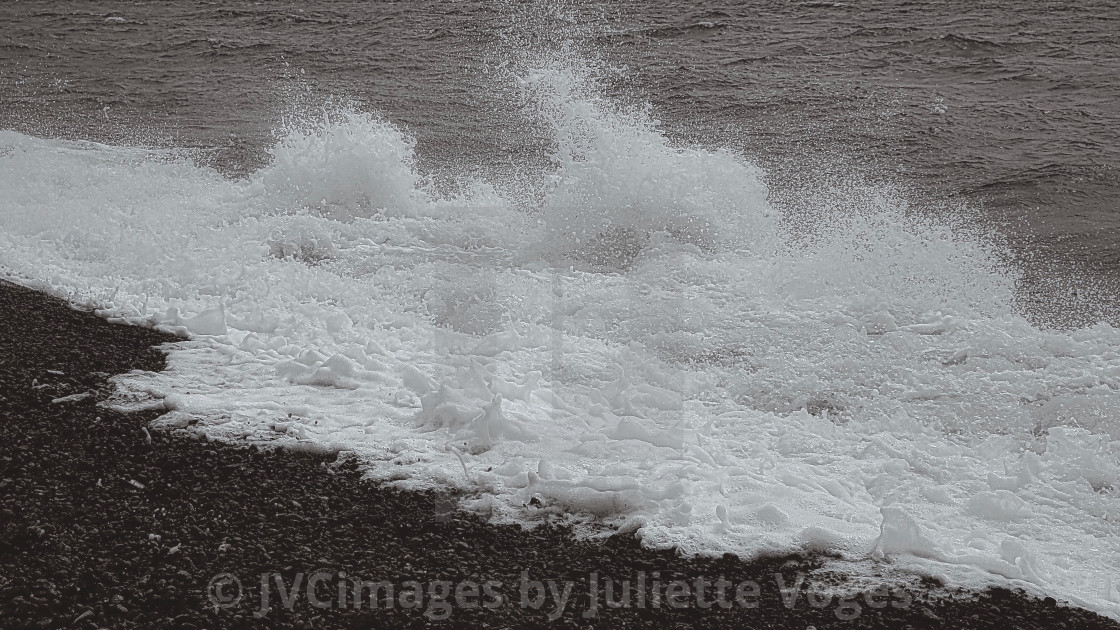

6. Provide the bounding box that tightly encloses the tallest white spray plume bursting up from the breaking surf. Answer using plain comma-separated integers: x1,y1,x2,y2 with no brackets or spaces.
523,61,774,262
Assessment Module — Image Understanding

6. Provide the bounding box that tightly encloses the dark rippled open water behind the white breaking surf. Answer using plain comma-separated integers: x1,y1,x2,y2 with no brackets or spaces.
0,0,1120,325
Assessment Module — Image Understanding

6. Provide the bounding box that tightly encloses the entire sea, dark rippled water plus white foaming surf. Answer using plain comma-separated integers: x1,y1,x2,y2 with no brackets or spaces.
0,1,1120,618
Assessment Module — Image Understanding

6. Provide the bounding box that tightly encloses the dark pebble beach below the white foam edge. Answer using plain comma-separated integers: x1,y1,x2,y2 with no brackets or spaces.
0,282,1120,630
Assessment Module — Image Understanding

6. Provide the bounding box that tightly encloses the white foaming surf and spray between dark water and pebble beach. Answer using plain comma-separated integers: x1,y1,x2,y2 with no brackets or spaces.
0,61,1120,615
